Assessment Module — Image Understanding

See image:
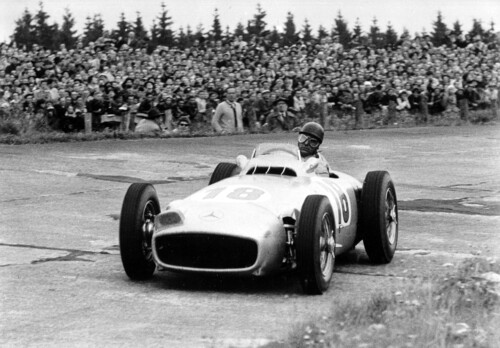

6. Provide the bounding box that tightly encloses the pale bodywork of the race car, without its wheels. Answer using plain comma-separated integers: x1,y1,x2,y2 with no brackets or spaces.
152,144,362,276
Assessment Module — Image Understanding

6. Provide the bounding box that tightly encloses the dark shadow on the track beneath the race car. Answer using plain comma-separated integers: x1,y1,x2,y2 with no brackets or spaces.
135,250,371,296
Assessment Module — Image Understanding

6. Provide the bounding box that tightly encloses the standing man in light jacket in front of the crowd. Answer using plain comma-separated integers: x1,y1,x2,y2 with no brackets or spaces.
212,87,243,134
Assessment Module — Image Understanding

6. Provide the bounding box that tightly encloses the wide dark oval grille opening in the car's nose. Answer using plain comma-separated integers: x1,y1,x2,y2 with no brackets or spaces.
155,233,257,269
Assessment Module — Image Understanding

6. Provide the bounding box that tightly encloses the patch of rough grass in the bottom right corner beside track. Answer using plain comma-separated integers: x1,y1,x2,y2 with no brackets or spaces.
287,258,500,348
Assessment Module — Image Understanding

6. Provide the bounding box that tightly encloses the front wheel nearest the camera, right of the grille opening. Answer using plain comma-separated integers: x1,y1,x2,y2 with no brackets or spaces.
296,195,335,295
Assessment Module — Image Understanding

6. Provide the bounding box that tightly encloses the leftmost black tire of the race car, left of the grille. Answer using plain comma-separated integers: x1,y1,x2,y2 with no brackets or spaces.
120,183,160,280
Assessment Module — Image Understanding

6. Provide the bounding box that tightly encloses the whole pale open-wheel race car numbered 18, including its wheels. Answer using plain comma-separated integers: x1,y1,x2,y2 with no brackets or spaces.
119,144,399,294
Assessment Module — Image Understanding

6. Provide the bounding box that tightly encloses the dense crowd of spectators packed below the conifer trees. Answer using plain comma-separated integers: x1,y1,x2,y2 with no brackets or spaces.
0,30,500,136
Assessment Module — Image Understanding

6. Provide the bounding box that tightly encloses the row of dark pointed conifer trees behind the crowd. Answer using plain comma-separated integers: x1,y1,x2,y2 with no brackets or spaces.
11,2,496,50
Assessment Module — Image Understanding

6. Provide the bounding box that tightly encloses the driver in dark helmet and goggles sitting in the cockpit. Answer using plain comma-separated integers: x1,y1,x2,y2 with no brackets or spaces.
298,122,330,175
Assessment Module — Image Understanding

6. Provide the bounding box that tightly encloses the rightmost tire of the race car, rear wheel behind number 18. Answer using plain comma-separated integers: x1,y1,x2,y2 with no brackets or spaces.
359,171,399,264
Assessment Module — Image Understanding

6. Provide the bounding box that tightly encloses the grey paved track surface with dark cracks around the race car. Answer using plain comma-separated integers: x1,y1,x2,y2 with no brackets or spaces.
0,126,500,347
